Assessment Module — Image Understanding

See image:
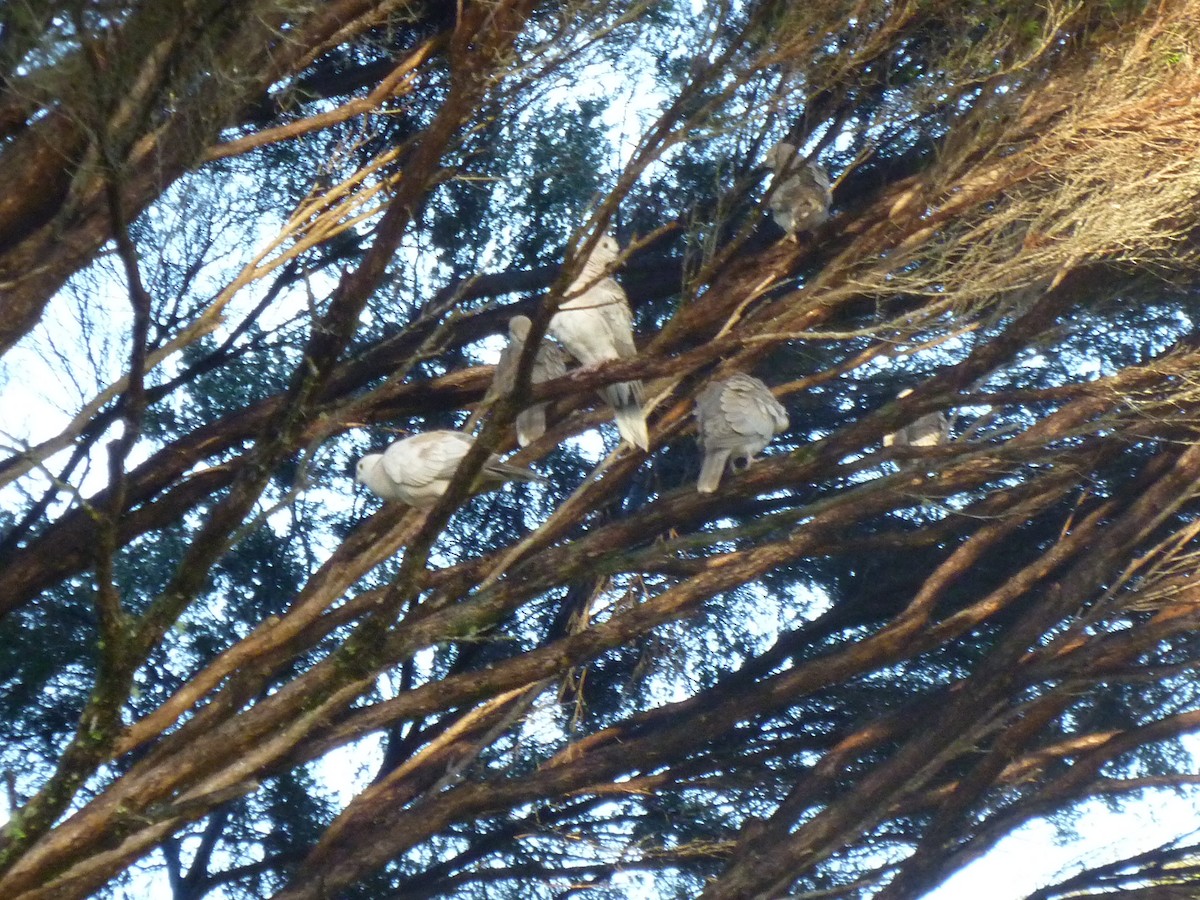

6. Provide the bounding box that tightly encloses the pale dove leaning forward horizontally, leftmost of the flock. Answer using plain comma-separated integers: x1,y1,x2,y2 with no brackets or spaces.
354,431,545,506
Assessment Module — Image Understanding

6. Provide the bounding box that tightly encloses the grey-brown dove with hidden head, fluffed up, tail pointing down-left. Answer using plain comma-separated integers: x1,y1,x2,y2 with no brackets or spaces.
695,372,787,493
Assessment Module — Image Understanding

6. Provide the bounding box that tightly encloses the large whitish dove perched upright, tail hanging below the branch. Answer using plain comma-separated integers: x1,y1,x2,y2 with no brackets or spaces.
547,234,650,450
